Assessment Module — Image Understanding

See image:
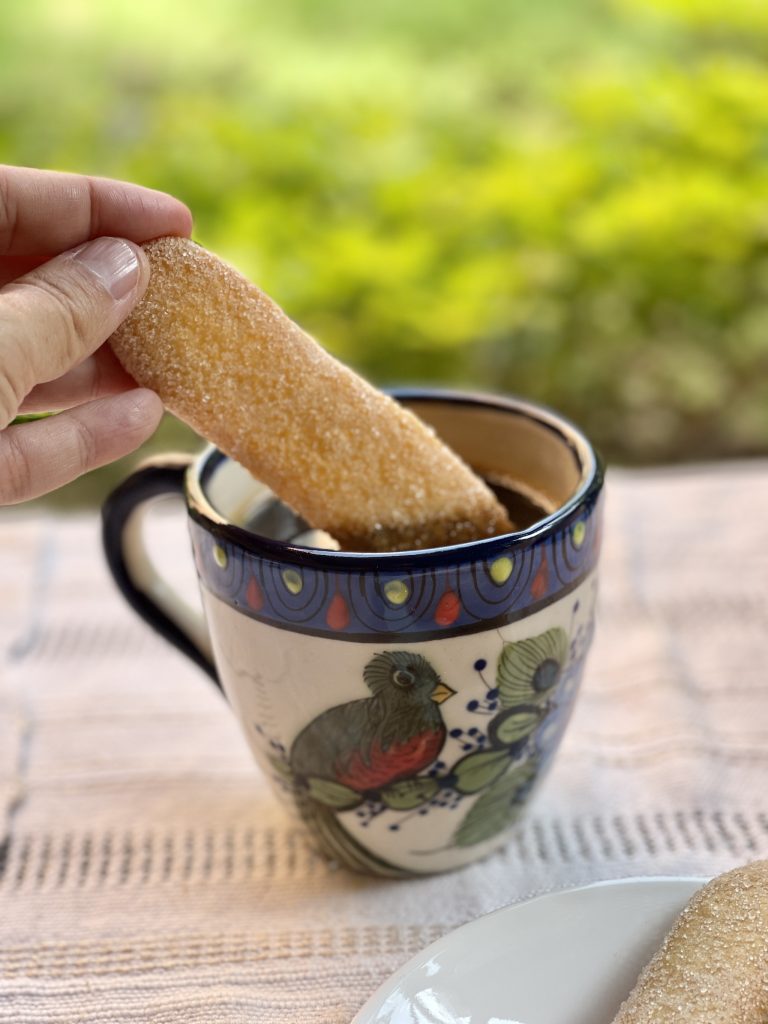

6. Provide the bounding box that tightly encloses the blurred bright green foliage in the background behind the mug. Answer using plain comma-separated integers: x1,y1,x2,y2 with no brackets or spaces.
0,0,768,500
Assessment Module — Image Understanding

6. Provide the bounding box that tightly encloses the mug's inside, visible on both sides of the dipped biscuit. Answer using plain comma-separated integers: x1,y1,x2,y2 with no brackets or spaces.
201,392,595,548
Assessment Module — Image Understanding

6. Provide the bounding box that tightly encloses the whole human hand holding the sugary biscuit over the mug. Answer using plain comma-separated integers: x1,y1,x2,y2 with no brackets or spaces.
0,165,191,505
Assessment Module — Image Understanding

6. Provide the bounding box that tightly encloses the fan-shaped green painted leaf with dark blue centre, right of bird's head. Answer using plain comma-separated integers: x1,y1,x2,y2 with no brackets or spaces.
496,626,568,708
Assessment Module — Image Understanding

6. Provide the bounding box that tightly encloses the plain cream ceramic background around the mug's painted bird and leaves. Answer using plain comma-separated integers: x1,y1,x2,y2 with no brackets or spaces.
203,573,597,874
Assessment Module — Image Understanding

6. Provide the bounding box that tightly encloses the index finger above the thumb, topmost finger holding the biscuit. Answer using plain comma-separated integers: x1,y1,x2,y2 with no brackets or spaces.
0,165,191,256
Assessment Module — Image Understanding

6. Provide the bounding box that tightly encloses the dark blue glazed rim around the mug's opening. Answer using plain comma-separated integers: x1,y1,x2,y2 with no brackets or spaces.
184,387,605,572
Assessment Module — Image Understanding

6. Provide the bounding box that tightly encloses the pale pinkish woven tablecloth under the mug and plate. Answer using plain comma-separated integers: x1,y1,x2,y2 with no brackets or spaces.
0,461,768,1024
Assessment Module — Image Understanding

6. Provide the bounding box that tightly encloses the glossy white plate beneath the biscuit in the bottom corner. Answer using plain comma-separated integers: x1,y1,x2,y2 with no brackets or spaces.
353,879,706,1024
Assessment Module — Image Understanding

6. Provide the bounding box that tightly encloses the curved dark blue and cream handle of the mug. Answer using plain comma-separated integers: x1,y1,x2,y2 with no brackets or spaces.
101,455,222,689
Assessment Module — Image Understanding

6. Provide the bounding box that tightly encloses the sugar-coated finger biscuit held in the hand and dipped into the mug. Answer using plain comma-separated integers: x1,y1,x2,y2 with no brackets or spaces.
111,238,513,551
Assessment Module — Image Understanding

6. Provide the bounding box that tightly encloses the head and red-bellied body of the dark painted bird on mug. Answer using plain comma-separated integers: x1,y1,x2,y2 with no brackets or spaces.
290,650,456,793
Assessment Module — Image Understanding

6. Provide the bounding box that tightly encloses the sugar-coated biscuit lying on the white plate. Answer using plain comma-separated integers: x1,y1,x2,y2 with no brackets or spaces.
613,860,768,1024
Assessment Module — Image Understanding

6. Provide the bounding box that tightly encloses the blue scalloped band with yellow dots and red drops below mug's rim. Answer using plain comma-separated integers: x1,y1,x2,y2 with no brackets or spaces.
189,489,602,643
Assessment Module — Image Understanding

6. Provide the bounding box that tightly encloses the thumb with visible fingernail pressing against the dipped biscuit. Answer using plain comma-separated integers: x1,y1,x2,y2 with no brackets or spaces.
0,238,150,430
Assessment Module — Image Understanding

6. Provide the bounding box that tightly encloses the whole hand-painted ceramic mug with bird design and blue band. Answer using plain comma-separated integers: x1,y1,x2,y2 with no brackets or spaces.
103,391,603,877
